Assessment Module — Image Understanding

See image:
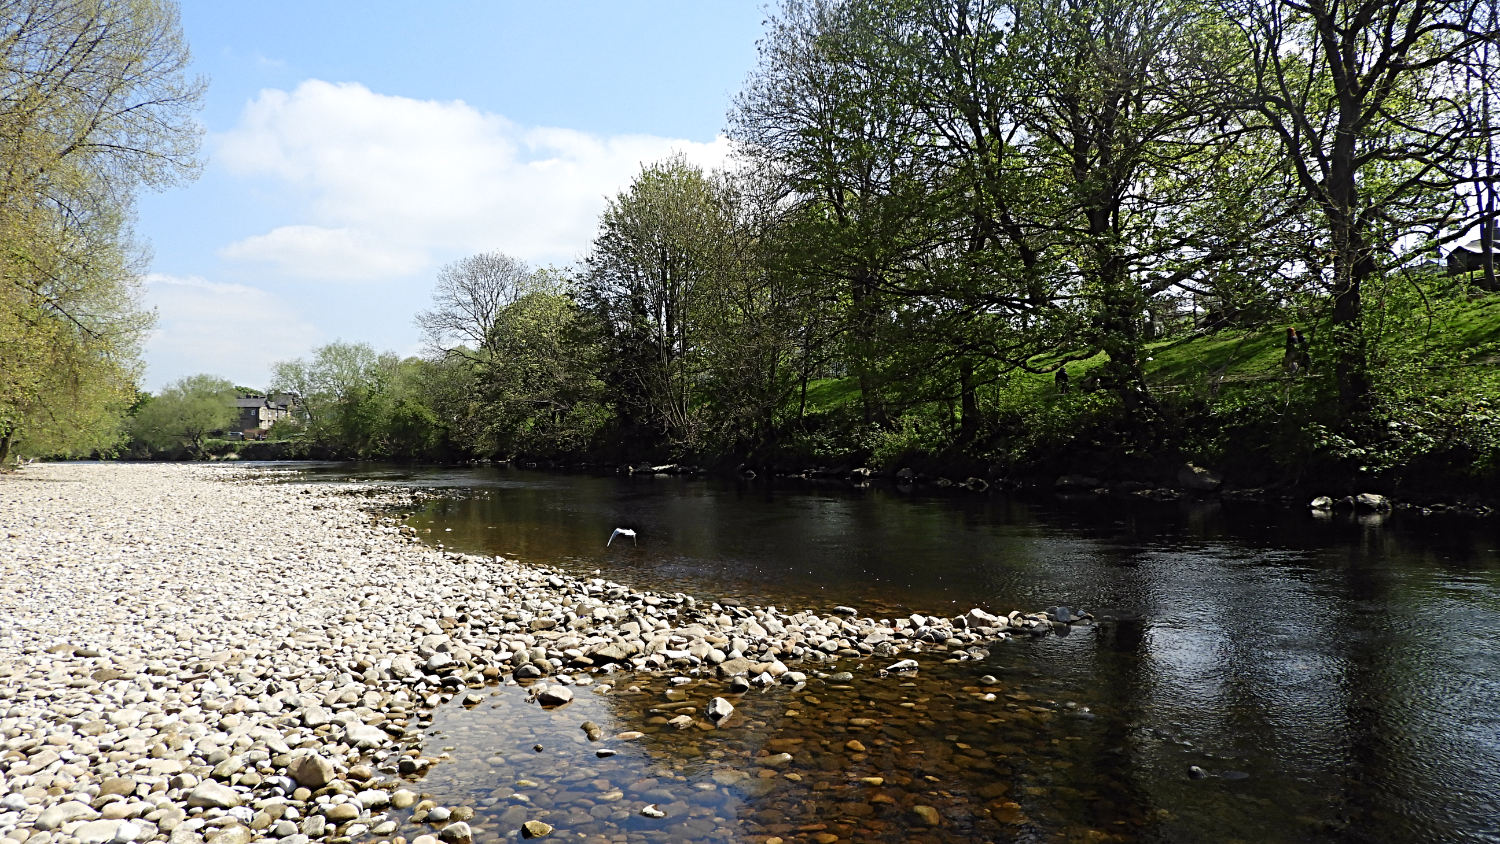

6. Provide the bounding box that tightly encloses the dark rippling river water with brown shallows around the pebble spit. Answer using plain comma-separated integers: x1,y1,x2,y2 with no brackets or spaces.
295,466,1500,844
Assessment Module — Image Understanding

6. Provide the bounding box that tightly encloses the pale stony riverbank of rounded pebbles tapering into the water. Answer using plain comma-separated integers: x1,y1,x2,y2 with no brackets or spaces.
0,465,1074,844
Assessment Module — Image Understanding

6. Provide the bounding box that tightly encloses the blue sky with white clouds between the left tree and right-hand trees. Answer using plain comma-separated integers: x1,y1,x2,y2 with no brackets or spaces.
138,0,765,390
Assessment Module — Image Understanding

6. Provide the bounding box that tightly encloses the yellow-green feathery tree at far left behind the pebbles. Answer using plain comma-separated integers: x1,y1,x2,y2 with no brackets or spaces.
0,0,204,456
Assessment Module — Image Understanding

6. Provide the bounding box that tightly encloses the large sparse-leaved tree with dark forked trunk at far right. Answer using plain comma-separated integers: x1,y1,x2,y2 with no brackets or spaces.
1224,0,1497,418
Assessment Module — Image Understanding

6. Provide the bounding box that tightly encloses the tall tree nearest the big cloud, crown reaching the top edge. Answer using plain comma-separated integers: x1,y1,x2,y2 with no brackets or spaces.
729,0,927,423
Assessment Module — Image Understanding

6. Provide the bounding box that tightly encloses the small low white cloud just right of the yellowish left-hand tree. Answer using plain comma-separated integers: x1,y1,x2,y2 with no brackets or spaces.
146,273,321,390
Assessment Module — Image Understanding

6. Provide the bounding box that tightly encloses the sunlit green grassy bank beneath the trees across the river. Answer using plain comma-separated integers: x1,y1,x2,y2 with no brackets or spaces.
782,295,1500,498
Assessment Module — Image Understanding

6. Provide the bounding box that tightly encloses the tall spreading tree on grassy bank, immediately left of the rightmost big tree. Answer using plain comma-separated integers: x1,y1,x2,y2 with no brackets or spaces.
1010,0,1242,402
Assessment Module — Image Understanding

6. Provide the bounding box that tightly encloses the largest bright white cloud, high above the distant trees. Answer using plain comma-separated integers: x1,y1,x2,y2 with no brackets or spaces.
216,79,729,279
